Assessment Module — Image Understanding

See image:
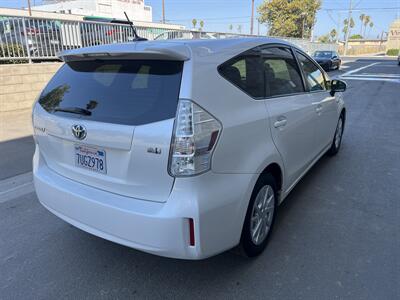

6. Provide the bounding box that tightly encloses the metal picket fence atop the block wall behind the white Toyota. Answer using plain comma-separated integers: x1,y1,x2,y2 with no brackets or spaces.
0,16,337,63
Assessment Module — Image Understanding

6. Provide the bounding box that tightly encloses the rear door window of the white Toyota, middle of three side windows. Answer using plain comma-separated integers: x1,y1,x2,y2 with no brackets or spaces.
261,47,304,97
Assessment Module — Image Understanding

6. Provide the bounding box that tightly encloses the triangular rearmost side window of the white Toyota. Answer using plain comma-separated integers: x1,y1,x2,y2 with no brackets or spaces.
218,50,264,98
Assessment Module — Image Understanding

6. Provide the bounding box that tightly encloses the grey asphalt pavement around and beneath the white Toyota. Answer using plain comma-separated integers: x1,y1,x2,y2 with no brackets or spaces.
0,58,400,299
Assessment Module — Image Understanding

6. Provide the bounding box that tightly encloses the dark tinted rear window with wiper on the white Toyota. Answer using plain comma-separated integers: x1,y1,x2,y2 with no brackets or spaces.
39,60,183,125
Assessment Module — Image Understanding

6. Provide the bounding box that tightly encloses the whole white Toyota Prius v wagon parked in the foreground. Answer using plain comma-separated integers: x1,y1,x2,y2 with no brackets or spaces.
33,38,346,259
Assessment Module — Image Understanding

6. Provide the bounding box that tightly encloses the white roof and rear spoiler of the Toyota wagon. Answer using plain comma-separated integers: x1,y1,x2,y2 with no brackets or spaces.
59,37,296,61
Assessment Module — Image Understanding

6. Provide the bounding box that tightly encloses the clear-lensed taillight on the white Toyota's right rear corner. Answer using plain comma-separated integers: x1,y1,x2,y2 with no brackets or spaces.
169,100,222,176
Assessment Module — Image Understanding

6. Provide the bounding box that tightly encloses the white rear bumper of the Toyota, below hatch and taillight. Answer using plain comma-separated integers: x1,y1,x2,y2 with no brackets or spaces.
33,149,254,259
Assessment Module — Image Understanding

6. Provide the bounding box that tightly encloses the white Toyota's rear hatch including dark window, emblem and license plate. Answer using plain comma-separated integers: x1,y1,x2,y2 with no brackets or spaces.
34,58,183,202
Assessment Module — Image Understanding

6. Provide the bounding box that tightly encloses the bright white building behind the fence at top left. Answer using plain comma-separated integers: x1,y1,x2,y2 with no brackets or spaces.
32,0,153,22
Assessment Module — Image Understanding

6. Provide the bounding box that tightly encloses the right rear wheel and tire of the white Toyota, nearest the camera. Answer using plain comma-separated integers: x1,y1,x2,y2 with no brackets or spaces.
240,174,277,257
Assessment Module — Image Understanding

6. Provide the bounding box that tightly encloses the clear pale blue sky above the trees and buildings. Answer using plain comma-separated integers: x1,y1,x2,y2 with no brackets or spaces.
0,0,400,38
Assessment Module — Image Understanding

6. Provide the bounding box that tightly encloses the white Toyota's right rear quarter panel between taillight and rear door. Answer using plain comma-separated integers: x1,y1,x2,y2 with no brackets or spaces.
180,49,283,177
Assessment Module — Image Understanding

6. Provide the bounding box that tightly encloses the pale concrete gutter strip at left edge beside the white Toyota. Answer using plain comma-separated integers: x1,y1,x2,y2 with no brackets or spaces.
0,172,34,203
